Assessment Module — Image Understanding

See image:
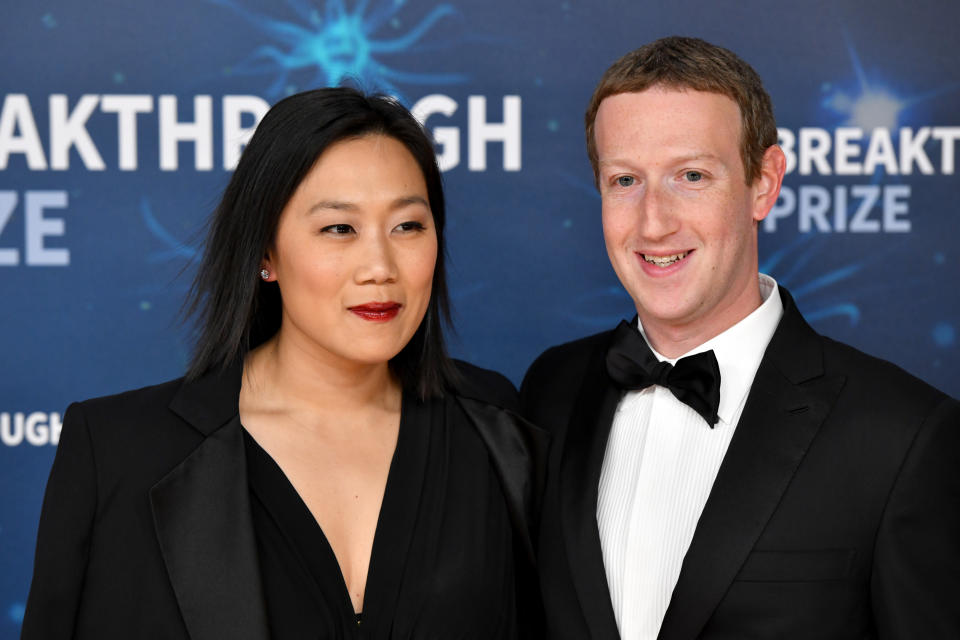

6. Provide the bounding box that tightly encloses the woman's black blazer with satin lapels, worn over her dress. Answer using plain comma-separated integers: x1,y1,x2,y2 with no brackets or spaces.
21,363,547,640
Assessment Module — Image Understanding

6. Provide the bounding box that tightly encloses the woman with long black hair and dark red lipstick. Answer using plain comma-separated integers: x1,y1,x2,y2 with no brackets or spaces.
23,89,544,640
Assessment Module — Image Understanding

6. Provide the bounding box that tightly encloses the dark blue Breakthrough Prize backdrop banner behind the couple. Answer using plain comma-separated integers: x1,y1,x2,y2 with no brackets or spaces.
0,0,960,638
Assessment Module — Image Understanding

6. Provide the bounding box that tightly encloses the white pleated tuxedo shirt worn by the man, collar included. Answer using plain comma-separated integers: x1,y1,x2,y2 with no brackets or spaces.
597,274,783,640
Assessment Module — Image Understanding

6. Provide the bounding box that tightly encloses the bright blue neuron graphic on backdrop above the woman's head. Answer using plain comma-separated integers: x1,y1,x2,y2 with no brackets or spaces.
210,0,466,100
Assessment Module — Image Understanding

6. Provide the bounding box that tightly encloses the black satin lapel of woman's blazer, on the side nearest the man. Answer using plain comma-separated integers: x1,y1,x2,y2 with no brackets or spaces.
457,396,550,562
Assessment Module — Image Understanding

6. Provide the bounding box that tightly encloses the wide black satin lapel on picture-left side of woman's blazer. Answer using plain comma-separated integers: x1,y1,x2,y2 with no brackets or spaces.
150,417,269,640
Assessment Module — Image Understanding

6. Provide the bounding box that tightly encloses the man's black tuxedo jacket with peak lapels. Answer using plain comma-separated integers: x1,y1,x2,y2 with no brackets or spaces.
521,288,960,640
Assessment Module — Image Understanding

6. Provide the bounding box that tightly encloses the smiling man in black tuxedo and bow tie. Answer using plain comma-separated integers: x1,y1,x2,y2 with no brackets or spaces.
522,37,960,640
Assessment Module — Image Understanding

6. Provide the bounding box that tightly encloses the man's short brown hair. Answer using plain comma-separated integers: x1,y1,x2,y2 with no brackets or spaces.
584,36,777,184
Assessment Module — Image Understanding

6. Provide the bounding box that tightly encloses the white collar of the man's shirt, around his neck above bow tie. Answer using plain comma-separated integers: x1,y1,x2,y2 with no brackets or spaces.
637,273,783,424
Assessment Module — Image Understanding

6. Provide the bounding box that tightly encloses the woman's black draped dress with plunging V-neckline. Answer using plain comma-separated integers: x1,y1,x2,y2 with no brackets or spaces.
245,395,528,640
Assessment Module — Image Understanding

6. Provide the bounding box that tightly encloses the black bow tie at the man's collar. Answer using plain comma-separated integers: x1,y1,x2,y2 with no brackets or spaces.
607,320,720,429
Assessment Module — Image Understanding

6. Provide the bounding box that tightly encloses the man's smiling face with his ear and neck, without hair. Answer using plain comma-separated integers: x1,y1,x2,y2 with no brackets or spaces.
595,87,782,355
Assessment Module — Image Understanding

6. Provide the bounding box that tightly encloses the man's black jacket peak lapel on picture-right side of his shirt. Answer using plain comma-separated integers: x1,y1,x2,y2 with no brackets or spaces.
658,288,845,640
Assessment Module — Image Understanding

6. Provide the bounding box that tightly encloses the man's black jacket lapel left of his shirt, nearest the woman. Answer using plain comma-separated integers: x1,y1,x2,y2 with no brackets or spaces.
560,349,622,640
